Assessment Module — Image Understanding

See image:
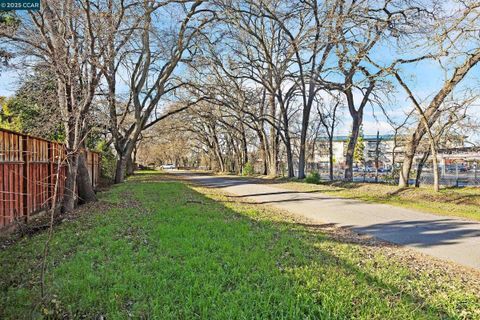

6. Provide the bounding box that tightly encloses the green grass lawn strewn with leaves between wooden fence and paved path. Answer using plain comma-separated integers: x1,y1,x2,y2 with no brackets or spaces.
0,173,480,319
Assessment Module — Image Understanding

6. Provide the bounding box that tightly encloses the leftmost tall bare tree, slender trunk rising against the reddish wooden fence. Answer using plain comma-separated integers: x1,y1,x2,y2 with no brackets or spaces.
0,0,103,211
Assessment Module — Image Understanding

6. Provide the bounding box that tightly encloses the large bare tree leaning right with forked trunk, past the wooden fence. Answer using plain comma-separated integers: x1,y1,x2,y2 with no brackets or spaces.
111,0,212,183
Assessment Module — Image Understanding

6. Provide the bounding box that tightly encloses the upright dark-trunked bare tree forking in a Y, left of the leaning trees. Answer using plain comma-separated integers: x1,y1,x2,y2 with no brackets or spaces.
320,0,432,181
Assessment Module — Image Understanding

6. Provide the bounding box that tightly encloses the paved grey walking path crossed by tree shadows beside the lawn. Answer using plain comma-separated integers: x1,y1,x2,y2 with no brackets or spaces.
177,172,480,270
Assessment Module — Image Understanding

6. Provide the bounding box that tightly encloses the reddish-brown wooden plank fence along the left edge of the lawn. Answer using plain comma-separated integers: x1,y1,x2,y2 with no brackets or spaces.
0,129,100,228
